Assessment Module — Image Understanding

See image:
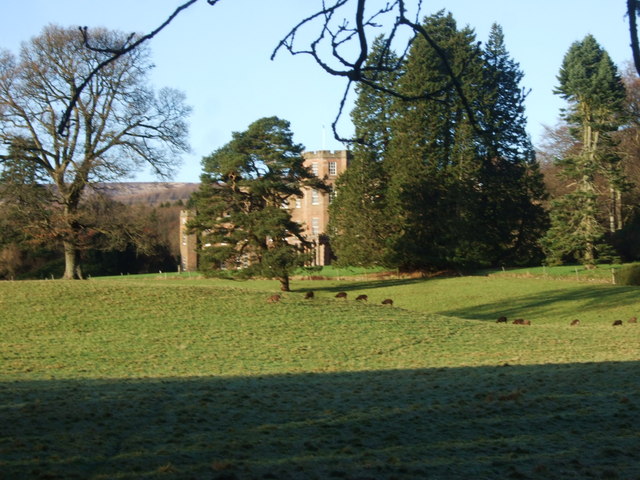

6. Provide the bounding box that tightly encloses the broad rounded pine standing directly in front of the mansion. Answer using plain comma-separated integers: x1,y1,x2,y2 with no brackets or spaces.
189,117,327,291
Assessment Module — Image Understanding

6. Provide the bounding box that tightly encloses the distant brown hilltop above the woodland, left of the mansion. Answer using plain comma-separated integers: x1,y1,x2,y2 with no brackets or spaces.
97,182,200,205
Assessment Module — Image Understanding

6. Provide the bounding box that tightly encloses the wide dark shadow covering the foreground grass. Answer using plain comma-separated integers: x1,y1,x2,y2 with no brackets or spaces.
0,362,640,479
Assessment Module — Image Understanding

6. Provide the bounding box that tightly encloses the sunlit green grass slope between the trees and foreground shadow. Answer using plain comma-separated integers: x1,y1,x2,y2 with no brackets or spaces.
0,277,640,379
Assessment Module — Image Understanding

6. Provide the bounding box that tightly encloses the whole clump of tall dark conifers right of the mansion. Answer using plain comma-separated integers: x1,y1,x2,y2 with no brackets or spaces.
331,11,545,269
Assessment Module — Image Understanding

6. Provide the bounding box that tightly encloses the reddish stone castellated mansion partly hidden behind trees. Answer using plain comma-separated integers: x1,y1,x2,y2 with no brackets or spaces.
180,150,351,271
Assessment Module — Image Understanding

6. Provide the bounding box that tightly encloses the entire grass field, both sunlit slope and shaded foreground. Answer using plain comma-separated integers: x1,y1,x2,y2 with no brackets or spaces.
0,272,640,479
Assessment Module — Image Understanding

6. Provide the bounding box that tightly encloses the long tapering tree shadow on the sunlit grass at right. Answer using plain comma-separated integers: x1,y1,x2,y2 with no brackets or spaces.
437,285,640,321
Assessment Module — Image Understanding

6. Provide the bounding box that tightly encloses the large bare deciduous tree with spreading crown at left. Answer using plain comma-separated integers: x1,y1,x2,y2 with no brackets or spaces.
0,26,190,279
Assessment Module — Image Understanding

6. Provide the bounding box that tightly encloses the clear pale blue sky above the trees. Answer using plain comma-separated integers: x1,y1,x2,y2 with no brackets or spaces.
0,0,631,182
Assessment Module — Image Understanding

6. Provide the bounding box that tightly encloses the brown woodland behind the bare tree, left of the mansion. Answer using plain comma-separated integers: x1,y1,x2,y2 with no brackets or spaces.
0,184,190,279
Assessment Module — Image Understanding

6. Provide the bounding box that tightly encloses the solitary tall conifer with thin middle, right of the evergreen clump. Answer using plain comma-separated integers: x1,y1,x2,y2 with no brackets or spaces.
545,35,625,266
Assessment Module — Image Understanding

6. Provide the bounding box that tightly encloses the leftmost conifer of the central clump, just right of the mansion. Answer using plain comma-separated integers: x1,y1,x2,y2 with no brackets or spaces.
329,37,400,266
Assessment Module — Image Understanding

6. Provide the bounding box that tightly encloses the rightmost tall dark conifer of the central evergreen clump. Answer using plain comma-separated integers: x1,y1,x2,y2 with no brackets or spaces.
478,24,548,264
